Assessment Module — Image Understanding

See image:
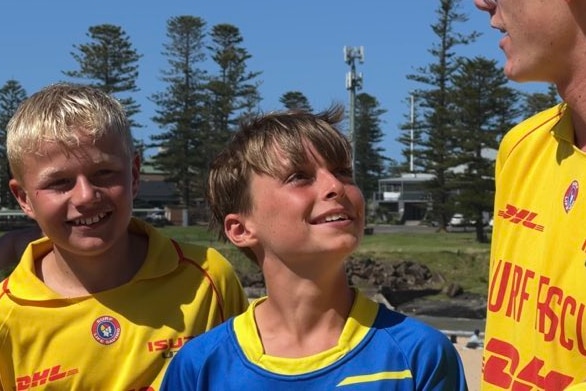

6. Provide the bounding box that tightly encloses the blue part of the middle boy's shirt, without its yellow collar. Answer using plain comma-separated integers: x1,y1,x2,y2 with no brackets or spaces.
162,298,467,391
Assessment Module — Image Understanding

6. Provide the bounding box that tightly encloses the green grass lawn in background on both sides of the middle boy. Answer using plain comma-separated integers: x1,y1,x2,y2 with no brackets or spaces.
0,226,490,294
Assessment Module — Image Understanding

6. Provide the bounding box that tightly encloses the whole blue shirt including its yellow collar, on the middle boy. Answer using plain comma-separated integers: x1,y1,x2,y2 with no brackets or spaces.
162,292,467,391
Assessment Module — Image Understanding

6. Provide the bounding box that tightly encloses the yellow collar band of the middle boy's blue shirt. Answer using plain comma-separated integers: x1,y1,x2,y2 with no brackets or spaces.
234,291,378,375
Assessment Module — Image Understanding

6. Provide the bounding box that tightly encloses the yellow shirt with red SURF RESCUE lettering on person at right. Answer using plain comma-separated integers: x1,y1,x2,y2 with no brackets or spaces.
482,104,586,391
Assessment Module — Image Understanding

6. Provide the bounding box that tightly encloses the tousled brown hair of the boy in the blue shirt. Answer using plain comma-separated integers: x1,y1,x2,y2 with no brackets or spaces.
207,105,352,253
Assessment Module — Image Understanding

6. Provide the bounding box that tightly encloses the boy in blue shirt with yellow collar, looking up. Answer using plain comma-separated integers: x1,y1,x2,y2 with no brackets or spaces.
162,106,467,391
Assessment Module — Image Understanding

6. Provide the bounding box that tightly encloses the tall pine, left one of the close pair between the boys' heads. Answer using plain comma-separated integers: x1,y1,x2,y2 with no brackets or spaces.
151,16,208,224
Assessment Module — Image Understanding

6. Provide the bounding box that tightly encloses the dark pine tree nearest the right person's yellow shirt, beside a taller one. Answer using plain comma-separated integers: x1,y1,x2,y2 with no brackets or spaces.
452,57,519,242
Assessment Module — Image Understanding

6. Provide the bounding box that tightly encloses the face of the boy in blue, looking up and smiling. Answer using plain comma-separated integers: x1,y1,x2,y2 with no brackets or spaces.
226,145,364,267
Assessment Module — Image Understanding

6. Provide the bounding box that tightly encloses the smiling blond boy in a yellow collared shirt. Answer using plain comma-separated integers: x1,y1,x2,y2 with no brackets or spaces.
0,84,247,390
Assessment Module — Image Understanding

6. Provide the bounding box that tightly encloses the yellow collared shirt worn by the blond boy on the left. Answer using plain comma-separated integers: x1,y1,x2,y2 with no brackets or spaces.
0,219,248,391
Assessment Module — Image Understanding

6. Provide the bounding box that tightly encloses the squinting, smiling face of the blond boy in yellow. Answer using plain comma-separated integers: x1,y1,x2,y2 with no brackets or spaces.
10,136,140,256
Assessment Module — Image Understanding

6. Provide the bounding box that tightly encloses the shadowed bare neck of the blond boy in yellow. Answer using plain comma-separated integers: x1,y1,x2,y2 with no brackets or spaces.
36,234,148,298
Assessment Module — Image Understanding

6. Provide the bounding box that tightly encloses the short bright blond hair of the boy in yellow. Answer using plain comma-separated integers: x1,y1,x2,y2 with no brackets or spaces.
6,83,134,180
